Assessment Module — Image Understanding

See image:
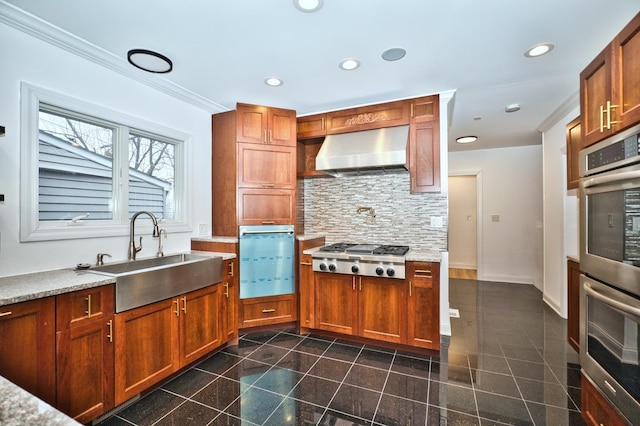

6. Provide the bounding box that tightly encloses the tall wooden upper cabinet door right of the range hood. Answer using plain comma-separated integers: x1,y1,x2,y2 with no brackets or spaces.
409,121,440,194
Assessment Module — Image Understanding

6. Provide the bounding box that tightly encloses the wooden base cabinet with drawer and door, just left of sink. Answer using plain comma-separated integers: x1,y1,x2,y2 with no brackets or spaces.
56,285,114,423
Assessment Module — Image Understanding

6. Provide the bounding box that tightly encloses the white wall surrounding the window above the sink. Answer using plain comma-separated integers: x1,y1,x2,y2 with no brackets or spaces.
0,24,211,276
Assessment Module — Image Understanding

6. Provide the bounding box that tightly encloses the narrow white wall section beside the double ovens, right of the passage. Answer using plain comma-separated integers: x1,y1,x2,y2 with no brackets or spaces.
542,107,580,318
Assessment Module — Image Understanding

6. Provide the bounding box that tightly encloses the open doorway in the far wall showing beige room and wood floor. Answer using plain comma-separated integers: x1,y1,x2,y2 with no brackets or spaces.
449,174,479,280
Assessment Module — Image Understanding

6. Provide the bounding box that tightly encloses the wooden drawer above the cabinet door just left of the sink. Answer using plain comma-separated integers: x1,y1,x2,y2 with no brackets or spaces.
56,285,115,331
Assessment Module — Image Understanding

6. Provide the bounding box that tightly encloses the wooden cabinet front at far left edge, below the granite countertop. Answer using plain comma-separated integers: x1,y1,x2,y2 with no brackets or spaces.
0,297,56,405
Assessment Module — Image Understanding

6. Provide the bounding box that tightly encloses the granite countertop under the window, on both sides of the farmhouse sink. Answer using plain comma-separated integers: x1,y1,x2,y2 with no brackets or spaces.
0,250,236,306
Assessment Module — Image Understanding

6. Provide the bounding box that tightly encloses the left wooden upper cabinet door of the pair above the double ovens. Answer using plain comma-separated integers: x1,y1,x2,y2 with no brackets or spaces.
580,46,613,147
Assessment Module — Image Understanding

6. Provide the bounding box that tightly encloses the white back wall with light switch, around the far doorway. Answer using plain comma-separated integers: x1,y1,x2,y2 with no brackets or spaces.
449,145,543,288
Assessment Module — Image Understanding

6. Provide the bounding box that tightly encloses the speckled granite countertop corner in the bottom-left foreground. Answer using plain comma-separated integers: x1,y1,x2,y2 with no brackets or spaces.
0,376,80,426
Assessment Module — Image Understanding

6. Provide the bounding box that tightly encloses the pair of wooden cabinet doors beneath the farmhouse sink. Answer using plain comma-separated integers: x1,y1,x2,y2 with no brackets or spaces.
114,285,222,404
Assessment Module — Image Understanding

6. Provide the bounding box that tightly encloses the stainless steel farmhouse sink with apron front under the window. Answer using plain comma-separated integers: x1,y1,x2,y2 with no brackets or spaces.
88,253,222,312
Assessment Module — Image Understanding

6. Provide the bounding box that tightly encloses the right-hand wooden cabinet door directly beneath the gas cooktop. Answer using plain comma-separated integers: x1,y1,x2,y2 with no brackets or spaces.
356,277,407,343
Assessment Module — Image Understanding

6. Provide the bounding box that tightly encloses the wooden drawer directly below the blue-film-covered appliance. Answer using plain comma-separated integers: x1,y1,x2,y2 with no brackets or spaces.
240,294,296,328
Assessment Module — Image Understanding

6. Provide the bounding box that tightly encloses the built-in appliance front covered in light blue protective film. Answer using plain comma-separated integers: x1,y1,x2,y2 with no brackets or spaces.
239,225,295,299
